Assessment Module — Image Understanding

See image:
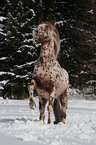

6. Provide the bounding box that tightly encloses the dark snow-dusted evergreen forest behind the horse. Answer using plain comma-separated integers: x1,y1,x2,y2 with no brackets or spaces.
0,0,96,99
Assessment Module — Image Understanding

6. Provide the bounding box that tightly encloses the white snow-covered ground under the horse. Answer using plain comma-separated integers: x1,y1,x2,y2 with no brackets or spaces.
0,93,96,145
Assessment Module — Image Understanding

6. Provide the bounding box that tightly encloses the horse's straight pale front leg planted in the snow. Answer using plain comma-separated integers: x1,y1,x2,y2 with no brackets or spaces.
48,87,55,124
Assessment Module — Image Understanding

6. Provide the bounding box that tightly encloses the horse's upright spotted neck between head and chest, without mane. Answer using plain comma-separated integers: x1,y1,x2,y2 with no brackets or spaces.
39,40,55,62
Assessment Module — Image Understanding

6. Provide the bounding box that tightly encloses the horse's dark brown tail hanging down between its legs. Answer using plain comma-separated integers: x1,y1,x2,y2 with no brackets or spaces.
53,98,62,124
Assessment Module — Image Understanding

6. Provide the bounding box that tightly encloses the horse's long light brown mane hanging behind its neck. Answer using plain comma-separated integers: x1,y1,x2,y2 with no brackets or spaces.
46,22,60,58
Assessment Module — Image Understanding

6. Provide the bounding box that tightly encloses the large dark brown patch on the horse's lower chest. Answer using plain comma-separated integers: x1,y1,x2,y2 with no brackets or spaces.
33,76,54,93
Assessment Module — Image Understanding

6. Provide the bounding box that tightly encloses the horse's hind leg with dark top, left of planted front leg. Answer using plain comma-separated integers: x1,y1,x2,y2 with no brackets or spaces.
39,98,47,121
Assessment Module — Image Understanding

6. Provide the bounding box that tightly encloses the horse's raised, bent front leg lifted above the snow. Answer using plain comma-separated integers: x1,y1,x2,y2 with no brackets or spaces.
28,80,36,109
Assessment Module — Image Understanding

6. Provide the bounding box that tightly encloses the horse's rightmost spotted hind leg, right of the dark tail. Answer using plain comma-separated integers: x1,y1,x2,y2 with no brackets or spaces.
59,89,68,124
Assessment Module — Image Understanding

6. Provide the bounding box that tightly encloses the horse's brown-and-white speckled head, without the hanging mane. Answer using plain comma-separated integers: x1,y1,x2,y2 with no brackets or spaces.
33,22,58,43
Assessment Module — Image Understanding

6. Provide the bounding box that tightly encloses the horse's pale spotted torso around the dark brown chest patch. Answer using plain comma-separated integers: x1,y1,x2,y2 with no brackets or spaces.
34,61,68,98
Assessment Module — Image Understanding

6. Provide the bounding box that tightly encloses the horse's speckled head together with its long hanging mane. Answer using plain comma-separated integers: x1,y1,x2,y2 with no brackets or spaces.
33,21,60,57
